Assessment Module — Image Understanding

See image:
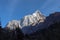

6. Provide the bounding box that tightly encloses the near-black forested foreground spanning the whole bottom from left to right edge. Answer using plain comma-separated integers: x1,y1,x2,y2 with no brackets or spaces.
0,22,60,40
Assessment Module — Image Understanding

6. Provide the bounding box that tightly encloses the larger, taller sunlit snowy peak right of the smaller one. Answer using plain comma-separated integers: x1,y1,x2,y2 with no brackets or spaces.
23,10,45,26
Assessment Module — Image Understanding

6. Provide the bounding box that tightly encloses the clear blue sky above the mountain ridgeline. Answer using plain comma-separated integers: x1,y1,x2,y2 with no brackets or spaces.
0,0,60,26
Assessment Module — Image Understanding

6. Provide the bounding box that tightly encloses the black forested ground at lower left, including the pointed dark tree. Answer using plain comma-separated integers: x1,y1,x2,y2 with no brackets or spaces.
0,27,24,40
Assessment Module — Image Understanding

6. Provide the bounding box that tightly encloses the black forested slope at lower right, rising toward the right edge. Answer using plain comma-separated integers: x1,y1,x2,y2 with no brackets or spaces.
26,22,60,40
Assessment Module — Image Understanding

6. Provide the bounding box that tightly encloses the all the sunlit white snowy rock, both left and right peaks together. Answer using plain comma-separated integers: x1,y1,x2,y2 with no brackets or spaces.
6,10,46,34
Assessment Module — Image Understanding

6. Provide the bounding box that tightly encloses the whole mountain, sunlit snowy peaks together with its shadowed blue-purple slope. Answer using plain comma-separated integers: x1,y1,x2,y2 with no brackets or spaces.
6,10,60,34
